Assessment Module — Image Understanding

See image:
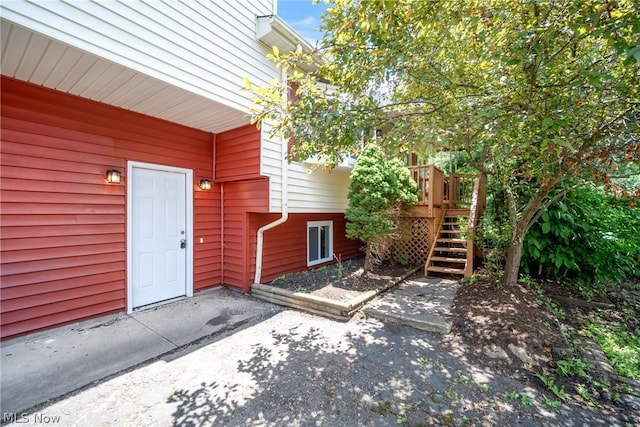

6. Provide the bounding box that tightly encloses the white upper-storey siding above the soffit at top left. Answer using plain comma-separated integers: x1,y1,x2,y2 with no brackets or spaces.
2,0,279,112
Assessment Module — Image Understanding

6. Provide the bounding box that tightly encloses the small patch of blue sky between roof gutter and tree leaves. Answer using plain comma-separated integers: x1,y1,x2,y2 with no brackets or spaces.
278,0,330,46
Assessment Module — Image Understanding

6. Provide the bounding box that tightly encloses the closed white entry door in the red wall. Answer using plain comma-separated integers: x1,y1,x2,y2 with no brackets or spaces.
128,166,191,309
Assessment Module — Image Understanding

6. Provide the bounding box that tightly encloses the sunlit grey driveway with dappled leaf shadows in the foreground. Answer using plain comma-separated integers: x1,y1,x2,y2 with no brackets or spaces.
7,310,629,426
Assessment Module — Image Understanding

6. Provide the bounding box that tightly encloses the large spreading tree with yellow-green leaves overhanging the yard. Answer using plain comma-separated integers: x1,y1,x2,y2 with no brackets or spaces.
252,0,640,284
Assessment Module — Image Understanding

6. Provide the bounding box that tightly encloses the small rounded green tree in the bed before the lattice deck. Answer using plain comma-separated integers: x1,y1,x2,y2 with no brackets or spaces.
345,144,418,271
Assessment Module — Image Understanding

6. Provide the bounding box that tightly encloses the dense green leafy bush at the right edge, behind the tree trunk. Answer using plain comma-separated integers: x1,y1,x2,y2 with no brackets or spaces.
522,187,640,288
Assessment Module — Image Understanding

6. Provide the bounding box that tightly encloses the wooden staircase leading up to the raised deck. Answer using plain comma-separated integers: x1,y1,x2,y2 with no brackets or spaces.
424,178,481,277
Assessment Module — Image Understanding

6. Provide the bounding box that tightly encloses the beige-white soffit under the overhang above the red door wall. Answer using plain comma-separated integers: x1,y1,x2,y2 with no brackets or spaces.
1,20,249,133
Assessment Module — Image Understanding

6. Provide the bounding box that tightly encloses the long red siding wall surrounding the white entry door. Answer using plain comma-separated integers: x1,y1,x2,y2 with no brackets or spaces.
0,77,222,338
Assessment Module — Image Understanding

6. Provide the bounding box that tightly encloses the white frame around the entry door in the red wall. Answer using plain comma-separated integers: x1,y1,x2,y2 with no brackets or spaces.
126,161,194,314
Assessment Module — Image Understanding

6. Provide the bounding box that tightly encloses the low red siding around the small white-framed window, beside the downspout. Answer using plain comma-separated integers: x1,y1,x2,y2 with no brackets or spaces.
249,213,362,283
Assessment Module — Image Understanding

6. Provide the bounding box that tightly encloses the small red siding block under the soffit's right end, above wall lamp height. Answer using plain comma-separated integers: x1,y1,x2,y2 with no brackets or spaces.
215,125,261,182
